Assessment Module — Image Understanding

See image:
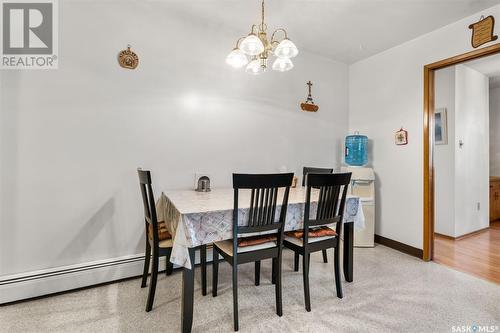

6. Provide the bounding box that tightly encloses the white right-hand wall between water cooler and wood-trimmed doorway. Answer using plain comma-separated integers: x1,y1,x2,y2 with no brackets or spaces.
349,1,500,249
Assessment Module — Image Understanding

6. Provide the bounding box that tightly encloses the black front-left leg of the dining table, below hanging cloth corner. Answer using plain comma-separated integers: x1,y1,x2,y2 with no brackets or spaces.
181,248,195,333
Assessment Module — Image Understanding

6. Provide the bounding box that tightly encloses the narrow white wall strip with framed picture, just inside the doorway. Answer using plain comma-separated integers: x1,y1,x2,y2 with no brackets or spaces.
434,66,455,237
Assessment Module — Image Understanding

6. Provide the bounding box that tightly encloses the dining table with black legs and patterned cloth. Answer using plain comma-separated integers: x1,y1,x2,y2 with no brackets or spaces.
156,186,364,332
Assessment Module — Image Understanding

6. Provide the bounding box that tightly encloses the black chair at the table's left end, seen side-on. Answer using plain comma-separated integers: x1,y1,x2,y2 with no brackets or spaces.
137,169,207,312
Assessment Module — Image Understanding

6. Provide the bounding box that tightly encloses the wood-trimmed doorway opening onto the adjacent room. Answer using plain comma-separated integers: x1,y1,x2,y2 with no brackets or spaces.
424,44,500,282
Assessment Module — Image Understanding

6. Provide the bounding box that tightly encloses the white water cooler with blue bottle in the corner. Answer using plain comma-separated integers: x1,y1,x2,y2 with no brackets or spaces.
342,133,375,247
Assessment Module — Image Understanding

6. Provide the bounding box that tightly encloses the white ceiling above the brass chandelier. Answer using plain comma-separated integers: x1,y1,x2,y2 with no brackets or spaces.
167,0,499,64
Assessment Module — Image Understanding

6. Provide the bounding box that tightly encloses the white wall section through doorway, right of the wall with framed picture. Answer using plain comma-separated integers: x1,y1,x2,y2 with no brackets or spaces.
455,65,490,237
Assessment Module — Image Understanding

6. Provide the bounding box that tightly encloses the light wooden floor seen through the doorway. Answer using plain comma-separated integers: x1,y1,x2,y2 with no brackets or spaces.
434,221,500,284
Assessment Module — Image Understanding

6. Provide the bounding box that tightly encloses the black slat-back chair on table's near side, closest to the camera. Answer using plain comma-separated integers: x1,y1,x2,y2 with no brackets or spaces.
212,173,293,331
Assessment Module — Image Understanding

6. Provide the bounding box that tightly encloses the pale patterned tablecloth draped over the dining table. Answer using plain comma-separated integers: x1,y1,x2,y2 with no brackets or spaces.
156,187,365,269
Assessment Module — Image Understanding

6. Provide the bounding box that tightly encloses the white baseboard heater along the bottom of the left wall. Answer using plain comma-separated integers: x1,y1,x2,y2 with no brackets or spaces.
0,249,212,304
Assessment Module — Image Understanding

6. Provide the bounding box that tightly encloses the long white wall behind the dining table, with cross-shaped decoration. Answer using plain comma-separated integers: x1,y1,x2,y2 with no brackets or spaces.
0,1,348,276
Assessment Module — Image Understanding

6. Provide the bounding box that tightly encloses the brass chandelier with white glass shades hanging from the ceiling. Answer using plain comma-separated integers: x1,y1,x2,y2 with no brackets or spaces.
226,0,299,75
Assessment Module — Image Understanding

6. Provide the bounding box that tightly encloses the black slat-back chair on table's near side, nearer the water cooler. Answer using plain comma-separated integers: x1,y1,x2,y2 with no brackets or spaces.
283,173,351,311
